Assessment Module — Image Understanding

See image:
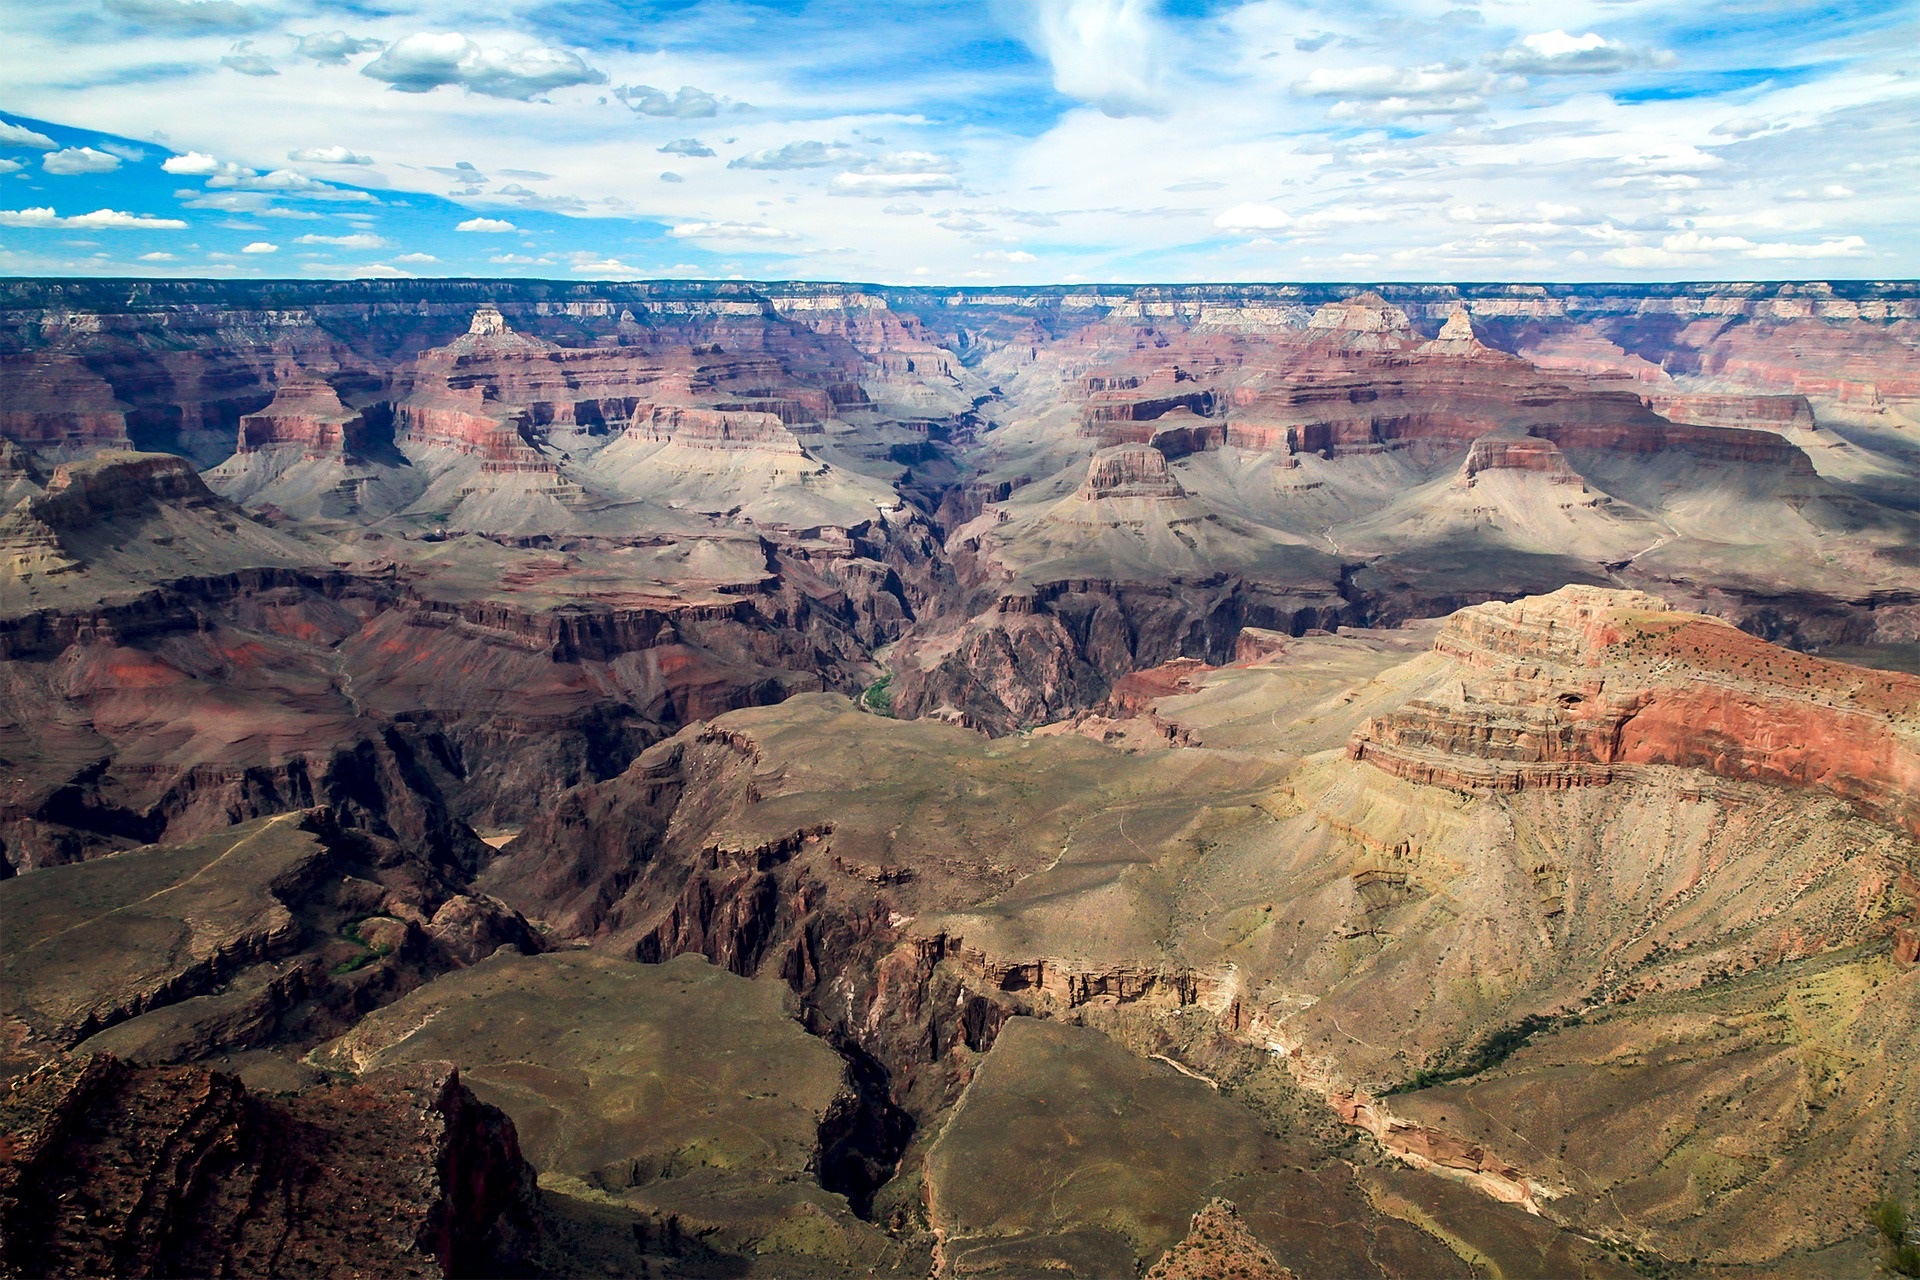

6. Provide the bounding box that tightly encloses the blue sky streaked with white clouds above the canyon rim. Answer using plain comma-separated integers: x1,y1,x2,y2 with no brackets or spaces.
0,0,1920,286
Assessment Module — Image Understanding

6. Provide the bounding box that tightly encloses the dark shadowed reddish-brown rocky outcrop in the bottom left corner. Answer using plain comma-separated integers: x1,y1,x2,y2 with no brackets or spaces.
0,1055,536,1276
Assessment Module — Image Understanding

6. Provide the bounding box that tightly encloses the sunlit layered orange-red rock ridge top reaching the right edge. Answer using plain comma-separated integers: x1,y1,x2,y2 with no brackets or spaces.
1348,587,1920,833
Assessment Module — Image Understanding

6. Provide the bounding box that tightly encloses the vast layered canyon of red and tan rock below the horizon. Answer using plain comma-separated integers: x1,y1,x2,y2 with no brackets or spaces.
0,280,1920,1280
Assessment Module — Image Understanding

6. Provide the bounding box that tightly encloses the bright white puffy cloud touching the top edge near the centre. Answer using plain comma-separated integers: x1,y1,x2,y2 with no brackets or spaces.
1002,0,1173,117
